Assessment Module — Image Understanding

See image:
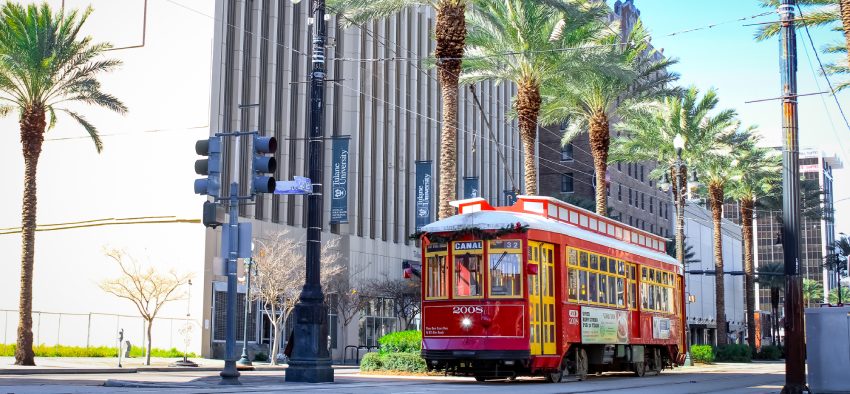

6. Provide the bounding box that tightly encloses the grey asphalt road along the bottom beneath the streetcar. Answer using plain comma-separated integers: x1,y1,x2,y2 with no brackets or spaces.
0,363,785,394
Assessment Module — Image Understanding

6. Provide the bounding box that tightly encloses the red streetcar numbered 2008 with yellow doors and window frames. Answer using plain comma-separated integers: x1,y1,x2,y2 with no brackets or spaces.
414,196,685,382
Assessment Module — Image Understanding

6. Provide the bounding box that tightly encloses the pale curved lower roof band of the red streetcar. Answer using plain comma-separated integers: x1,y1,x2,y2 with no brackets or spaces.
422,210,682,267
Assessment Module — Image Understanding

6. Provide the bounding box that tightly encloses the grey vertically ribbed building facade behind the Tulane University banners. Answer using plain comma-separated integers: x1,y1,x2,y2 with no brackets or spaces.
203,0,523,357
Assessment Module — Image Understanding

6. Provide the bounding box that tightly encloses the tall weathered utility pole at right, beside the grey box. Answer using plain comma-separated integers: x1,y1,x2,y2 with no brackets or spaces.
779,0,809,394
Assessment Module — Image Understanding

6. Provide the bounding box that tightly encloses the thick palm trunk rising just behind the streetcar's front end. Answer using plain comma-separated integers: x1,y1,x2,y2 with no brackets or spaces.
434,0,466,219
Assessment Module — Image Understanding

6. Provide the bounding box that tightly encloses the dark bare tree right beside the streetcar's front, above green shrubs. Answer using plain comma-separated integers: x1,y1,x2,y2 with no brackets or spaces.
366,275,422,330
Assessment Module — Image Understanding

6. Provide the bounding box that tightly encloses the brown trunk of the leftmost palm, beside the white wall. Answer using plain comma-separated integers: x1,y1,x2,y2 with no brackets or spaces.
15,106,46,366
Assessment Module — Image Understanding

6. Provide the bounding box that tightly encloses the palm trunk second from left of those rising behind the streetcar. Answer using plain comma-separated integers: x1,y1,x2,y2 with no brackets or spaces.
516,79,541,196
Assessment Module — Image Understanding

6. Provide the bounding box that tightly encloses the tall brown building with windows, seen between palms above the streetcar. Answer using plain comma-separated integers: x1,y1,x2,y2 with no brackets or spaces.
538,0,673,237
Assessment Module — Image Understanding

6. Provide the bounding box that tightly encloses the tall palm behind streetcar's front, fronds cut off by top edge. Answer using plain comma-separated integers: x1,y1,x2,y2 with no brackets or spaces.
327,0,471,219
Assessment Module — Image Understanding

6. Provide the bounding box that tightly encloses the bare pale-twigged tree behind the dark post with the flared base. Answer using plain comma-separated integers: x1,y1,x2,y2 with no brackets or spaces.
251,230,343,364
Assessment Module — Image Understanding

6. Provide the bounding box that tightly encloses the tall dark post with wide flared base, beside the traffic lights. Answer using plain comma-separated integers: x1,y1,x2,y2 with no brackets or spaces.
286,0,334,383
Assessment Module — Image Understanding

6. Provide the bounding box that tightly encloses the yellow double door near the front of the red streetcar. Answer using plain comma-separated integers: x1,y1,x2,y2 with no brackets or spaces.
528,241,556,355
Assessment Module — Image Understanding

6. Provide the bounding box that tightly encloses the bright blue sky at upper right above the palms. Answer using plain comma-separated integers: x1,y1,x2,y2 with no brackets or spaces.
632,0,850,234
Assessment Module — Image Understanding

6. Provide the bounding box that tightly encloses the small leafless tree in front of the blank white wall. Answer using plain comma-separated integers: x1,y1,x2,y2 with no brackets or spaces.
100,249,192,365
